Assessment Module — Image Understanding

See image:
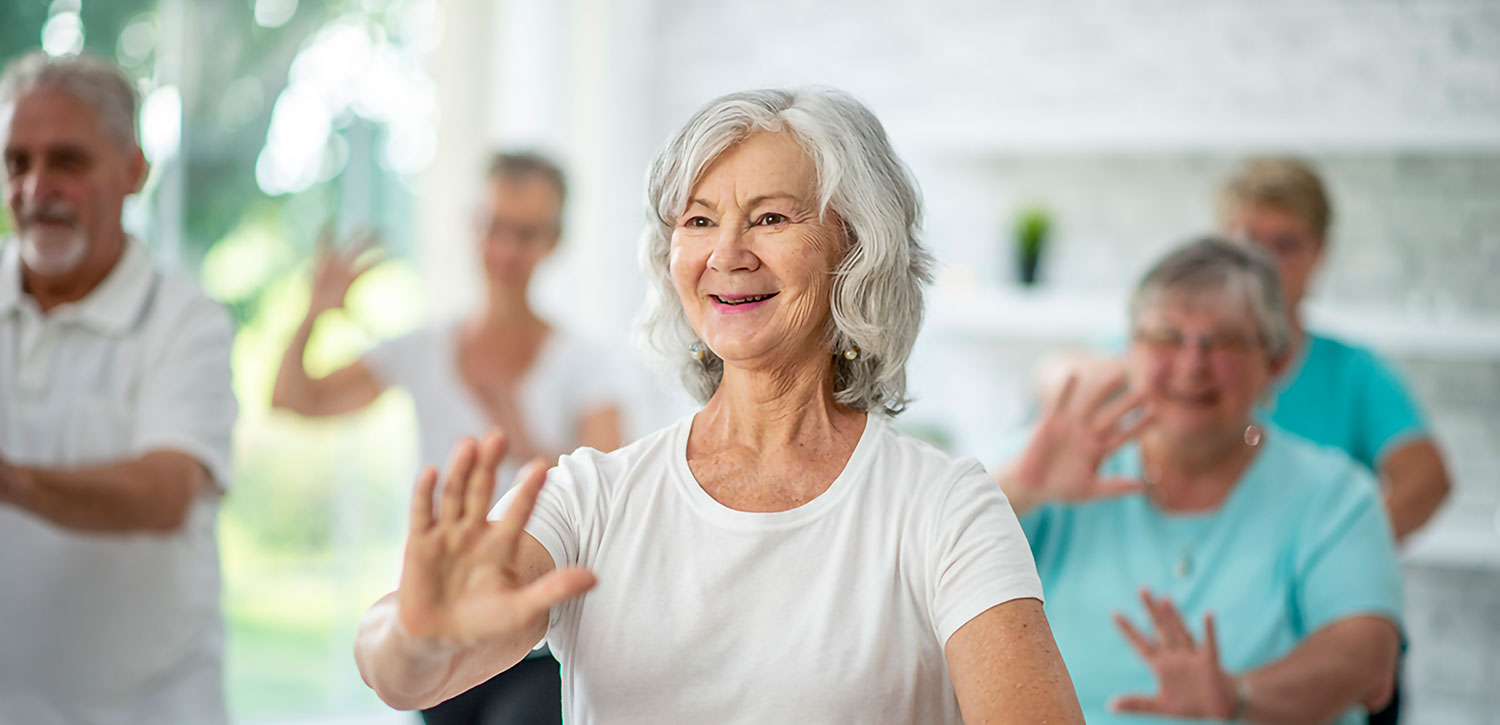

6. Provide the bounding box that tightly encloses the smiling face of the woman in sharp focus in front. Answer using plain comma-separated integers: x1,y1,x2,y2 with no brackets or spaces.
669,132,845,376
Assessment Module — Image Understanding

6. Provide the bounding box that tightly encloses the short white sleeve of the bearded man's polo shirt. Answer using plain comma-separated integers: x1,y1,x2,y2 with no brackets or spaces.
132,297,239,491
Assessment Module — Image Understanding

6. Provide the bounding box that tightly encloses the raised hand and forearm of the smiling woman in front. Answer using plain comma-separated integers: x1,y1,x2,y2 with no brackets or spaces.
354,434,596,708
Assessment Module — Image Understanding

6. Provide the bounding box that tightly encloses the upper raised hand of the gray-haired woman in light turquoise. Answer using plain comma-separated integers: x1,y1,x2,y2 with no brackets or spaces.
1016,372,1151,501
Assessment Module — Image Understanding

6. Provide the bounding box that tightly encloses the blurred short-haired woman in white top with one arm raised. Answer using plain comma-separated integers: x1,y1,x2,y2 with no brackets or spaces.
272,153,621,725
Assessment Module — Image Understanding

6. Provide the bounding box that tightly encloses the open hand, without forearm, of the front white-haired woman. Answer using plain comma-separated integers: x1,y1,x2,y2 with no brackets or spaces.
396,434,594,647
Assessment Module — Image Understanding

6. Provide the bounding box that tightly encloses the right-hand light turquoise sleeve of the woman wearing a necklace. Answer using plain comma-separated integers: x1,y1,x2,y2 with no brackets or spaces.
1293,459,1401,633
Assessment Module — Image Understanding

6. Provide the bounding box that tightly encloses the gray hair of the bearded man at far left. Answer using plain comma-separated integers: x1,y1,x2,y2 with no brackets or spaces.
0,53,140,150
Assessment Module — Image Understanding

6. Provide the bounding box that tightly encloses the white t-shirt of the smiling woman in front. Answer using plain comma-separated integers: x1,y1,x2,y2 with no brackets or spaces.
510,416,1041,723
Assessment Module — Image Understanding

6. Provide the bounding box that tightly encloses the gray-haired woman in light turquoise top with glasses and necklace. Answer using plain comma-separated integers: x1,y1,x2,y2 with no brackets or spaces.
996,239,1401,723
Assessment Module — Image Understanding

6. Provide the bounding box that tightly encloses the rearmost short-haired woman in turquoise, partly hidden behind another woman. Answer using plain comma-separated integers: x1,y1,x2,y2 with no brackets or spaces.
1220,156,1449,540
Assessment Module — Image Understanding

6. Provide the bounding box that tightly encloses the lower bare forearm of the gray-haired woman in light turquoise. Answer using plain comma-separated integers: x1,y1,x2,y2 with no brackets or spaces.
1241,617,1400,725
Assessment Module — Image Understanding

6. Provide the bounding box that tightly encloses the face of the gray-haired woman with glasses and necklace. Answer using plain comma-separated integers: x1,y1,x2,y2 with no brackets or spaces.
1128,293,1280,438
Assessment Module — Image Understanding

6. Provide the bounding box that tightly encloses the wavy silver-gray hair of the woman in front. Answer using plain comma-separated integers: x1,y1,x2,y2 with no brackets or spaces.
638,87,932,416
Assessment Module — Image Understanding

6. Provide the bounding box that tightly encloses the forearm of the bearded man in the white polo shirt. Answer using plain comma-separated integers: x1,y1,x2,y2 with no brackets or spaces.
0,452,209,533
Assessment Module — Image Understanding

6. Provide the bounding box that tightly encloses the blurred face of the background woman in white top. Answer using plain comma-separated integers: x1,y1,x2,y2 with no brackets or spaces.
476,177,563,290
